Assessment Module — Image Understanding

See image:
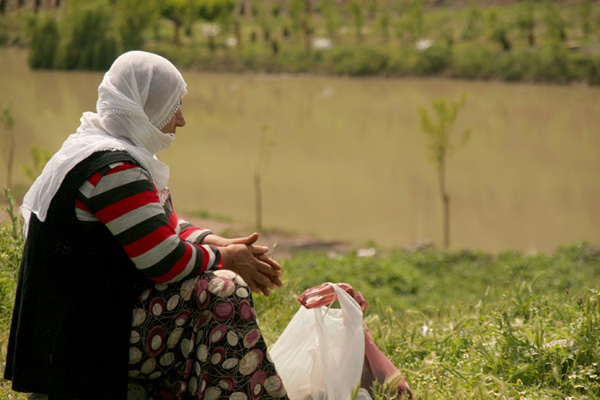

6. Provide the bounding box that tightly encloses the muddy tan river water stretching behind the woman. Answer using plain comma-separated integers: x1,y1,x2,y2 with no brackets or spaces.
0,49,600,251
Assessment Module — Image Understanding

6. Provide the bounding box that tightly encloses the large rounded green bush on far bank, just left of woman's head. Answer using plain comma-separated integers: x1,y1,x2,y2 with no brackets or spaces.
56,0,118,70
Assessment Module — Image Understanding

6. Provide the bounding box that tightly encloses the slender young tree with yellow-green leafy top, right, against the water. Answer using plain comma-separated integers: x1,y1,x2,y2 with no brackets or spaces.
419,94,470,248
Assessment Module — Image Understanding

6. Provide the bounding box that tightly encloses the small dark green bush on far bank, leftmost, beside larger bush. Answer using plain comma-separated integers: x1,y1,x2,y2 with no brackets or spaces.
28,13,60,69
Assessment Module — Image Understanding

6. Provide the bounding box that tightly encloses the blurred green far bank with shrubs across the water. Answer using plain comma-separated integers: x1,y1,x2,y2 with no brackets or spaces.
0,0,600,85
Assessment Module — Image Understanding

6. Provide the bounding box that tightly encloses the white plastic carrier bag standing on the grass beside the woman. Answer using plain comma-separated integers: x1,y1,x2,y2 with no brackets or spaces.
269,284,365,400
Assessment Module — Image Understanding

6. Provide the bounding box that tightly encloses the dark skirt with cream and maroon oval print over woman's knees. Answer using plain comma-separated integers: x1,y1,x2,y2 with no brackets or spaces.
129,270,287,400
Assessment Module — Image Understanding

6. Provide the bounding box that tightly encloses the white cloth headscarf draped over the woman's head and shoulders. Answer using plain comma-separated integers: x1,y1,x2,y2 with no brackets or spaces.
21,51,187,233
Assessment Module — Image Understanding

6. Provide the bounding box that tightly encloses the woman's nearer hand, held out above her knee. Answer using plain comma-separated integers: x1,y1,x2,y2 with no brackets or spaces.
219,242,282,296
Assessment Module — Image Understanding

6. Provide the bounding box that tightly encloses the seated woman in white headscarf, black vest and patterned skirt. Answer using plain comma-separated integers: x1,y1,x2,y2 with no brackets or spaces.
5,51,286,400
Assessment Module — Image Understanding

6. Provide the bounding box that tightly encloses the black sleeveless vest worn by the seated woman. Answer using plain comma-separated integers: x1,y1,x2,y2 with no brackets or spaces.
5,151,140,400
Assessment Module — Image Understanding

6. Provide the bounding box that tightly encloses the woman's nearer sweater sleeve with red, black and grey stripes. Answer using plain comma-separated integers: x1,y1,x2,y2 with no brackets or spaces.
75,163,222,283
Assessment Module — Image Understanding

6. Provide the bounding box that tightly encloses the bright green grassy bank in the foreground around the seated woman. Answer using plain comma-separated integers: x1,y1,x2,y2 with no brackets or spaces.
0,193,600,399
